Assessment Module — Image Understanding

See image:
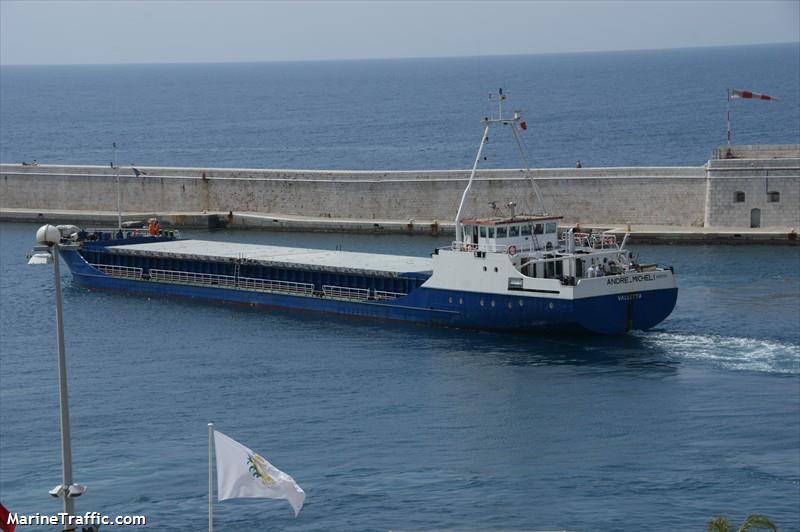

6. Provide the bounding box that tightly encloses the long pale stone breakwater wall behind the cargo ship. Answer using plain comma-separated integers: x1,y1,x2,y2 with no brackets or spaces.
0,150,800,227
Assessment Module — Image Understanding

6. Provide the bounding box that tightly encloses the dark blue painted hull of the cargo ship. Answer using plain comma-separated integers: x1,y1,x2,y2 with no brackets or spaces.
62,251,677,334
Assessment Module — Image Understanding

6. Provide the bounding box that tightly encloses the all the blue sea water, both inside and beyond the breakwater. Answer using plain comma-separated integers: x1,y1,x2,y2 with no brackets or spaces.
0,45,800,531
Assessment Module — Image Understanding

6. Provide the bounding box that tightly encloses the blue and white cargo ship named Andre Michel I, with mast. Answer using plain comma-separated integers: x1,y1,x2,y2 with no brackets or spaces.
48,91,678,333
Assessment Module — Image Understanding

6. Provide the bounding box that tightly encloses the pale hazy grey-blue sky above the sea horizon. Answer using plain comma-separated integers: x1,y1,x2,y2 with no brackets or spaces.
0,0,800,65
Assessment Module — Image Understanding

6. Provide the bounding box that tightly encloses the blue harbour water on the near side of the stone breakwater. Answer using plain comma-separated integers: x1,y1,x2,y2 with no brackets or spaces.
0,224,800,531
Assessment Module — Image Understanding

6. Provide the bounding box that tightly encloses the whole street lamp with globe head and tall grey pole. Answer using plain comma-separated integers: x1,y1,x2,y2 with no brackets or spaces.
28,225,86,531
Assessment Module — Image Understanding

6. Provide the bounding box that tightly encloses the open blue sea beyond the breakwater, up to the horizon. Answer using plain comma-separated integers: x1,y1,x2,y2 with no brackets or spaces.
0,43,800,169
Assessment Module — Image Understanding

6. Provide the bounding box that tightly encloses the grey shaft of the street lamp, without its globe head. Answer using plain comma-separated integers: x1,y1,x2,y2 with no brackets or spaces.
52,244,75,530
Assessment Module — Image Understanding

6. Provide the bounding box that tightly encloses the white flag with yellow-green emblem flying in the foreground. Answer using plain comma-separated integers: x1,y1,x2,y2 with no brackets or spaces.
214,430,306,517
